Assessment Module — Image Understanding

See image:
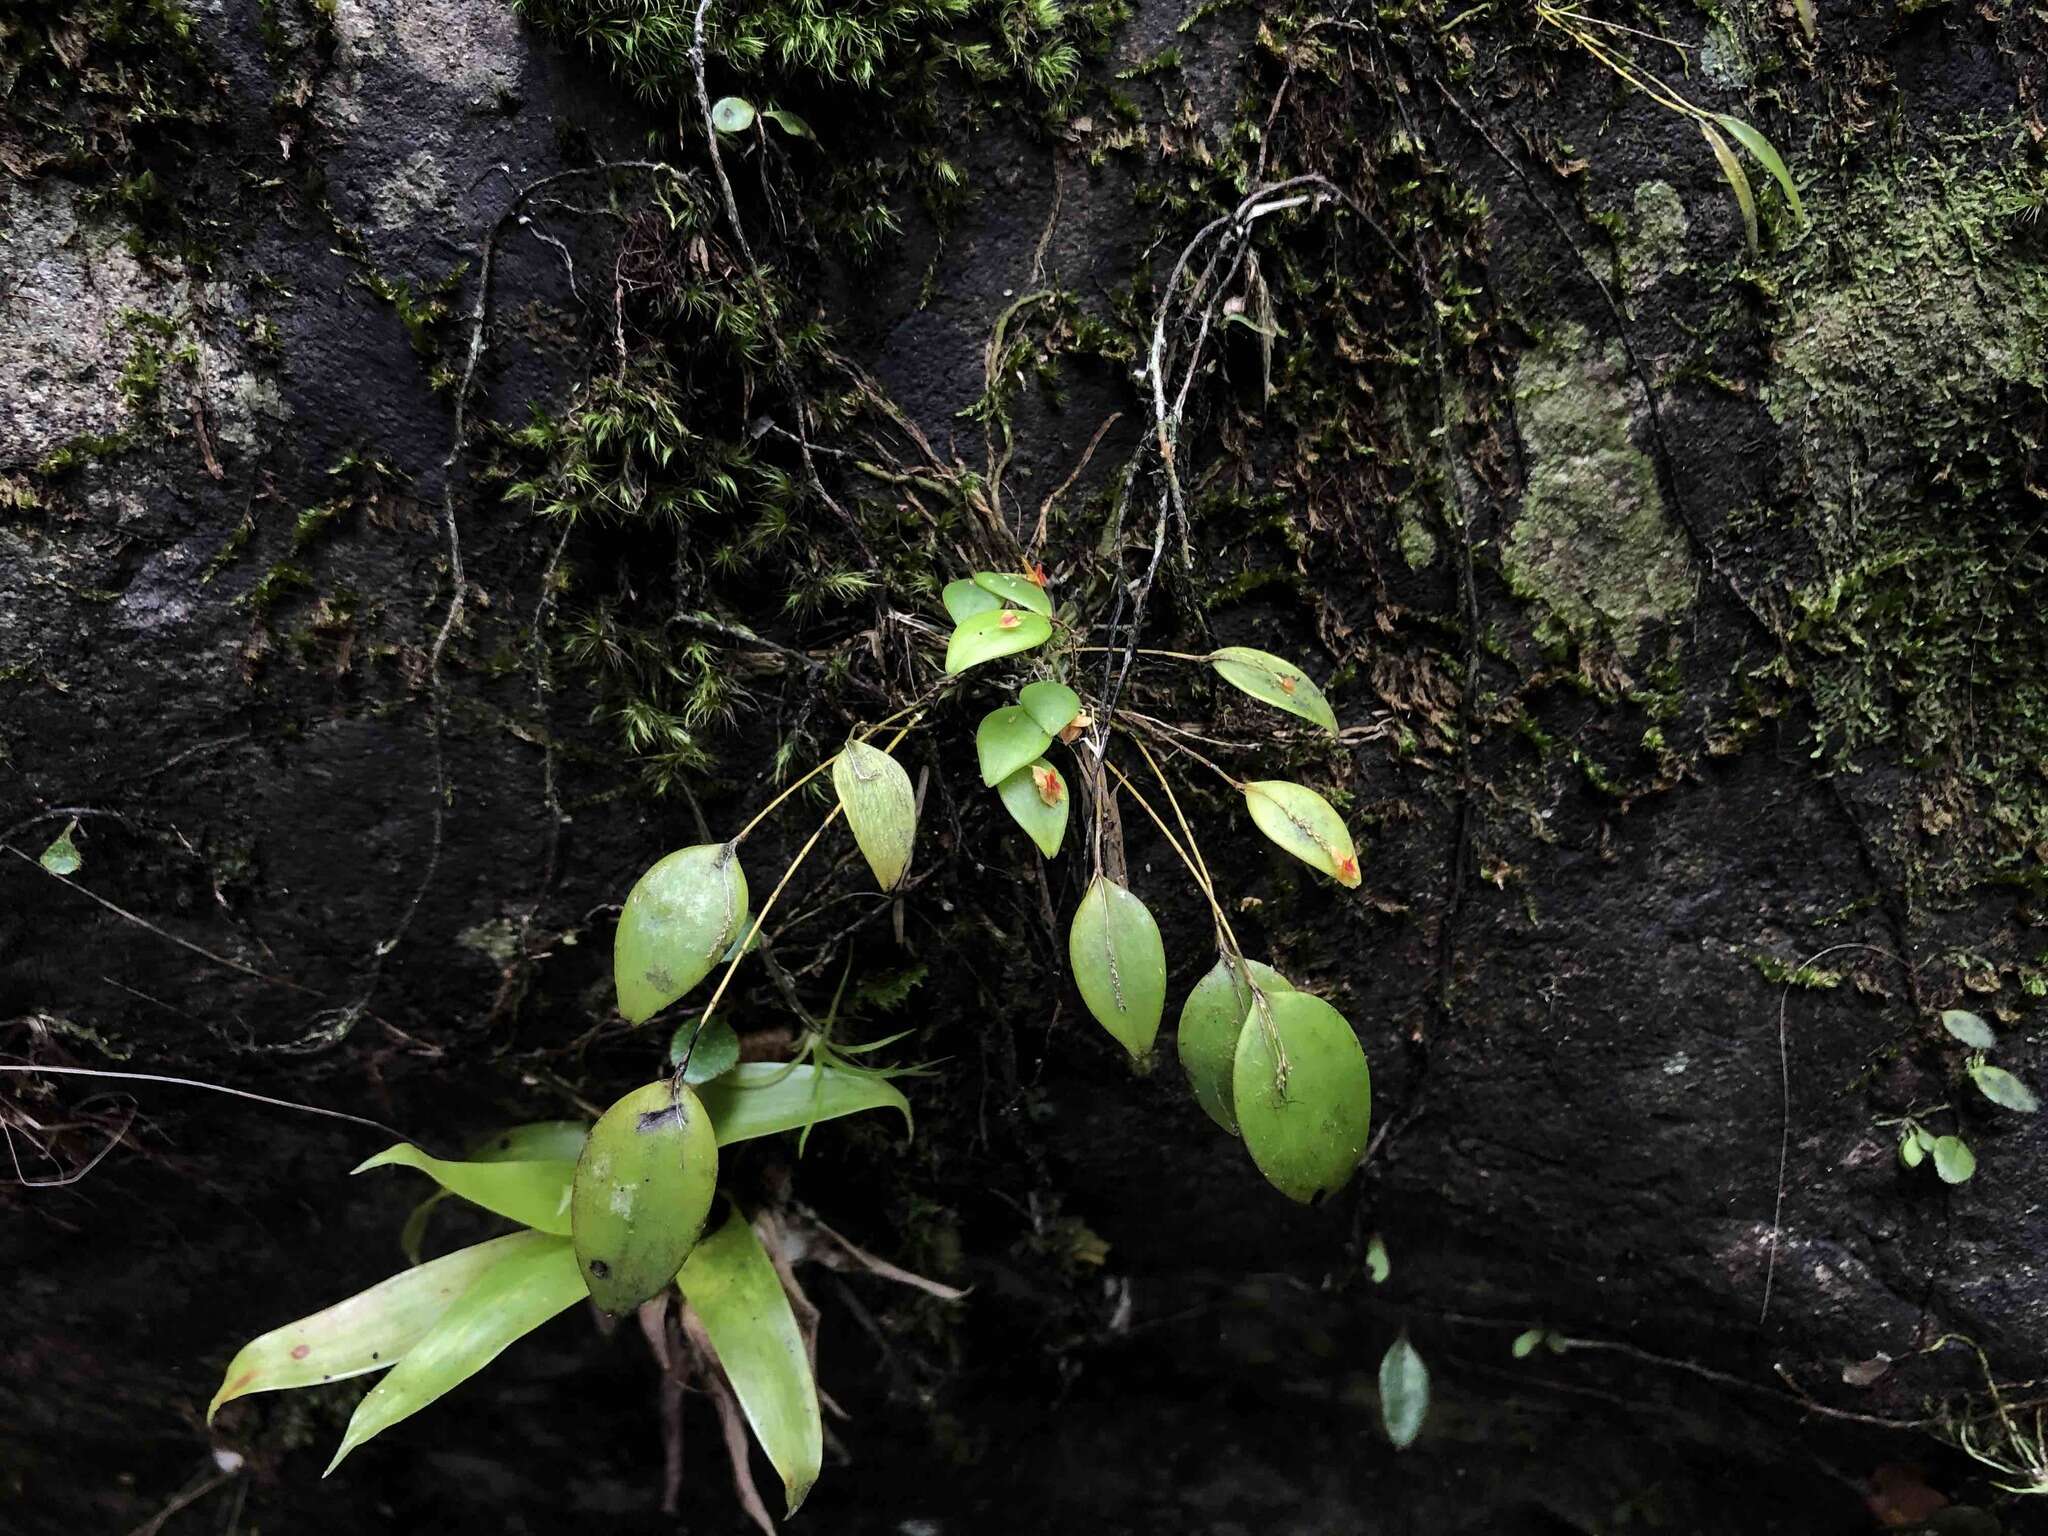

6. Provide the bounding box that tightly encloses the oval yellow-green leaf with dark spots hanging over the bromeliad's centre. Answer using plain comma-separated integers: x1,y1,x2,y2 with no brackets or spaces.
569,1077,719,1315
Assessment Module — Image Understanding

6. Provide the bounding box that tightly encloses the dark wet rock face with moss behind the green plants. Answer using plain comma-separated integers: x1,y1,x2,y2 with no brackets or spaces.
0,0,2048,1536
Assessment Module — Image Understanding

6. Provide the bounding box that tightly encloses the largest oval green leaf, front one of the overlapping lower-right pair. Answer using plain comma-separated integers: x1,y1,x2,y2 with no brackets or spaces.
1231,991,1372,1204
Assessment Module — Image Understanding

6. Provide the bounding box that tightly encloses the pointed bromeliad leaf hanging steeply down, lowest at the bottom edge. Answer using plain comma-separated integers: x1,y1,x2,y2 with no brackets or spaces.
678,1212,825,1513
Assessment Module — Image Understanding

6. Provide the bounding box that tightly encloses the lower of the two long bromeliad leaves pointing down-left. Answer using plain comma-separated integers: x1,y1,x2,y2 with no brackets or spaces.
328,1237,584,1473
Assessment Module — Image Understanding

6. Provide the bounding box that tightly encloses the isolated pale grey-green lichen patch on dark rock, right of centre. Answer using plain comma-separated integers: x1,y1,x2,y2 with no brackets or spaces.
1501,326,1694,655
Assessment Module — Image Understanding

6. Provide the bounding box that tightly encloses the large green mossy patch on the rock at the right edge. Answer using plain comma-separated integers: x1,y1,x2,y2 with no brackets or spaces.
1765,140,2048,891
